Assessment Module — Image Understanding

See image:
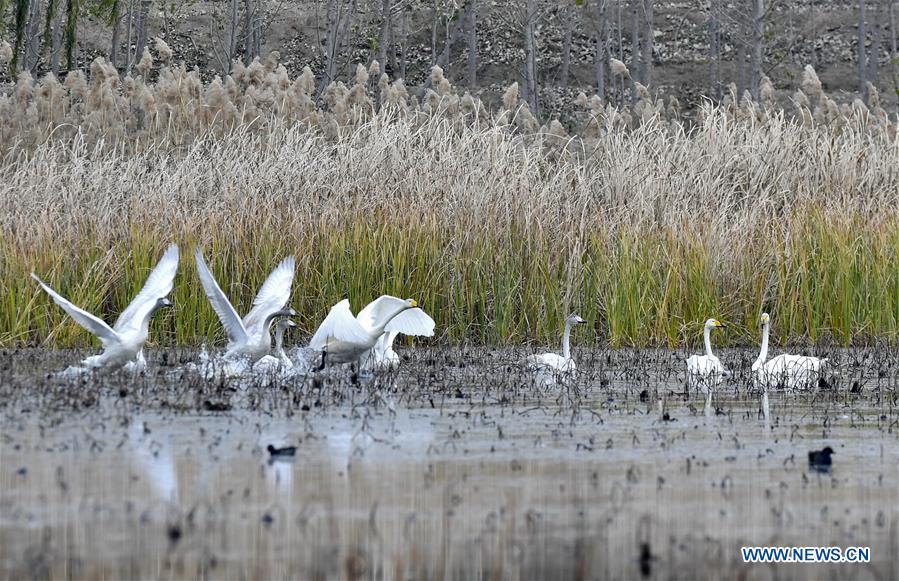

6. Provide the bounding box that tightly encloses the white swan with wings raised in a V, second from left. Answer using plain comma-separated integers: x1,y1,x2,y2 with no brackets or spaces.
196,250,296,363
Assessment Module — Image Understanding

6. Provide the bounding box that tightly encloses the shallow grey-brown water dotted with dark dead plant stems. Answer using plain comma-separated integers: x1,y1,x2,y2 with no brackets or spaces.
0,348,899,579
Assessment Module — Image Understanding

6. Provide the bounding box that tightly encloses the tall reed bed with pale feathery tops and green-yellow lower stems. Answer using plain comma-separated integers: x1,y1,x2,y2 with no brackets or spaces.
0,45,899,346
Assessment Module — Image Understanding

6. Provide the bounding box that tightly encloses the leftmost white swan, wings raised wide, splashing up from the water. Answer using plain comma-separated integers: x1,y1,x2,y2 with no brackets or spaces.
31,244,178,370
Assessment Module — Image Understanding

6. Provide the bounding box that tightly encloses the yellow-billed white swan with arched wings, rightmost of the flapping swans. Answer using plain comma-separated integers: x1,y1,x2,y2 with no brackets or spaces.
309,295,434,369
